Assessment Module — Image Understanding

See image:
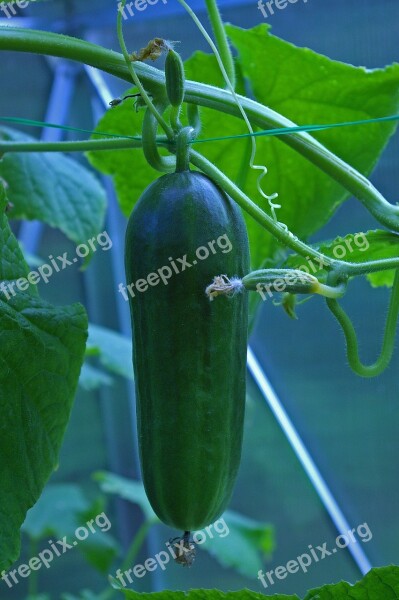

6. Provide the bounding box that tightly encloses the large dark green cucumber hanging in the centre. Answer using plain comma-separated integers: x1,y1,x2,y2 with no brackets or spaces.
125,171,249,531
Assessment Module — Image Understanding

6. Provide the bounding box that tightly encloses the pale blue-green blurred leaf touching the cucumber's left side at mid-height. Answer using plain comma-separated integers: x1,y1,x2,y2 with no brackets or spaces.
87,323,133,379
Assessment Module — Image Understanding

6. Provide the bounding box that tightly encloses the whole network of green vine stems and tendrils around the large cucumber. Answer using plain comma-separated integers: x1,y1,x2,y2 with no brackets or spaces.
0,9,399,377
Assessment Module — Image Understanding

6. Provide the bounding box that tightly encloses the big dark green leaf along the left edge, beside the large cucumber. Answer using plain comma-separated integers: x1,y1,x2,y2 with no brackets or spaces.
0,193,87,571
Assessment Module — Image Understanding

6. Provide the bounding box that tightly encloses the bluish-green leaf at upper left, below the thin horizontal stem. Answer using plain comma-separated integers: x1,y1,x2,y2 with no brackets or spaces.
0,127,106,244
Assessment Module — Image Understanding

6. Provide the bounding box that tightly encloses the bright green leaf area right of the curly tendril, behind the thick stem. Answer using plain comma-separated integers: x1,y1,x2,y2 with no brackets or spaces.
227,24,399,267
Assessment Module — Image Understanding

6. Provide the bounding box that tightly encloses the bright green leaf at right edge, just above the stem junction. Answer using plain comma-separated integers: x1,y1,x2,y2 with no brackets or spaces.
284,229,399,287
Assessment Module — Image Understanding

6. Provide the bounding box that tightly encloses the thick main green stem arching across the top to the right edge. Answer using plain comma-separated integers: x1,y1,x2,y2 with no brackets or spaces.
0,27,399,231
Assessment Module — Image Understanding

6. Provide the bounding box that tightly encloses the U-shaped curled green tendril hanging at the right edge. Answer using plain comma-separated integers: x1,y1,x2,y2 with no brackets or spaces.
326,269,399,377
